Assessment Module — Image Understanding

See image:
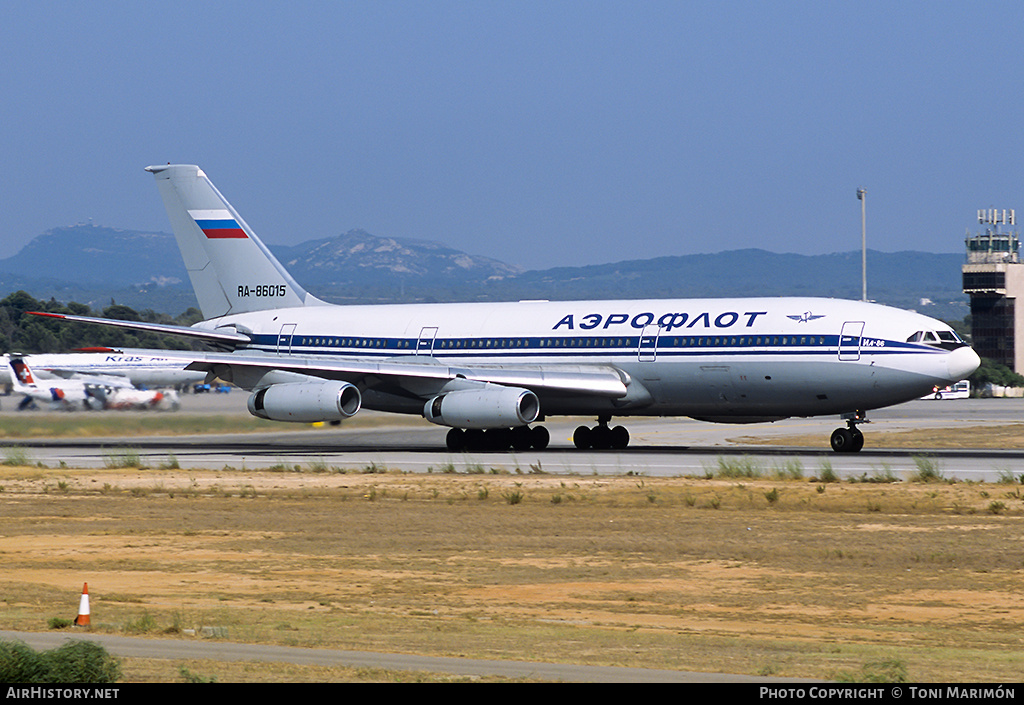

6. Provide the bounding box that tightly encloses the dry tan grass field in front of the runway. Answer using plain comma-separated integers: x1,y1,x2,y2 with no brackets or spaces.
0,465,1024,682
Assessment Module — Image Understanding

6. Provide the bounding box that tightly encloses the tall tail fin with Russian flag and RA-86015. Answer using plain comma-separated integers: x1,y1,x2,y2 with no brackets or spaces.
145,164,323,319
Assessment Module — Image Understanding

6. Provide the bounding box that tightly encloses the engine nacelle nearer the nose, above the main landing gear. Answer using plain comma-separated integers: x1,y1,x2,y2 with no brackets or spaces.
423,384,541,428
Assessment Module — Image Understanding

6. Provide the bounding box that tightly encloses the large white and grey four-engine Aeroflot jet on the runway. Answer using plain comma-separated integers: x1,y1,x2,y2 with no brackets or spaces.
28,164,980,452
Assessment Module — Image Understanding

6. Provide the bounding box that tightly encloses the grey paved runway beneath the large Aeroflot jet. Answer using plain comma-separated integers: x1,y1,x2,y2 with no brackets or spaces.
4,392,1024,482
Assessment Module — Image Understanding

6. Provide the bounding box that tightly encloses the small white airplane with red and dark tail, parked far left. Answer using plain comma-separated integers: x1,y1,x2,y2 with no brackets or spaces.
10,357,179,411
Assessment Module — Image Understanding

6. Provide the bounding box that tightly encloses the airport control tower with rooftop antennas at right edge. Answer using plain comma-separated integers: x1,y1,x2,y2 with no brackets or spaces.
964,208,1024,373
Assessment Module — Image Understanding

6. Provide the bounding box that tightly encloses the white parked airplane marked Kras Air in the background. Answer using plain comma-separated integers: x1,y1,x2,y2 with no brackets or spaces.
0,347,206,388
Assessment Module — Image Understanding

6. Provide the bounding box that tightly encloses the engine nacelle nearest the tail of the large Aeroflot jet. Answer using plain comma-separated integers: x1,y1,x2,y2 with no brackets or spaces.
248,381,362,423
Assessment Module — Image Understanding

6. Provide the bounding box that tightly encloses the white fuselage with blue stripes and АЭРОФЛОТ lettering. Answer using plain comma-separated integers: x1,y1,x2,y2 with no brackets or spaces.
198,298,978,422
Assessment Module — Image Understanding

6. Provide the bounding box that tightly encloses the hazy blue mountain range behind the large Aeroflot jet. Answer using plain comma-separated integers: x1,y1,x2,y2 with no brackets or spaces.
0,225,968,320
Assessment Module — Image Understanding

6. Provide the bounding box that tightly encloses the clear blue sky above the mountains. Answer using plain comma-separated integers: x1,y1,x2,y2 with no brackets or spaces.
0,0,1024,268
